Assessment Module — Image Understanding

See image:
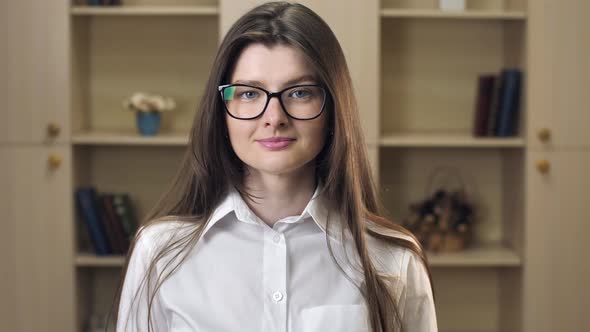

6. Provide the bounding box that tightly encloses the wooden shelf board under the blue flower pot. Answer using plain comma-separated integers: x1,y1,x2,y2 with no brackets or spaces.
72,130,188,146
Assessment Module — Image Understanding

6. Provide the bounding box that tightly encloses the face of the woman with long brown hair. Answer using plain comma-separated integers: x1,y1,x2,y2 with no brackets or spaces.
226,44,327,179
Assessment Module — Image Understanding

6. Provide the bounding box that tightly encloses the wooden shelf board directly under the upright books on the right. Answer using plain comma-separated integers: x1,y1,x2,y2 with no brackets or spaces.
379,133,525,148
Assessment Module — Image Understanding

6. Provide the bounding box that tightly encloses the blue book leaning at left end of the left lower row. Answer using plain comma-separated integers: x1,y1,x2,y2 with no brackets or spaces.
75,187,113,255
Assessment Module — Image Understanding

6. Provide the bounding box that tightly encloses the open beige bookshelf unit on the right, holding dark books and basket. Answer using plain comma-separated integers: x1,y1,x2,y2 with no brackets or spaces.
377,0,528,331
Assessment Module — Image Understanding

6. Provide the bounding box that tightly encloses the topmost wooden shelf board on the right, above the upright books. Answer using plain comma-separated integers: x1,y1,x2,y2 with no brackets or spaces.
381,9,527,20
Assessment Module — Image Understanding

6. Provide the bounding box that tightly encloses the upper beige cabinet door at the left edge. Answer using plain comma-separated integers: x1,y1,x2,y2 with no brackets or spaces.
0,0,70,143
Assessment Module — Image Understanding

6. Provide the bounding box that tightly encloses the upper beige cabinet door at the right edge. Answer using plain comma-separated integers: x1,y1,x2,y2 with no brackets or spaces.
527,0,590,147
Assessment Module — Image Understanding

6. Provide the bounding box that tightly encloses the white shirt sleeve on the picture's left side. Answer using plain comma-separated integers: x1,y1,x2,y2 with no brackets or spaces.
116,229,169,332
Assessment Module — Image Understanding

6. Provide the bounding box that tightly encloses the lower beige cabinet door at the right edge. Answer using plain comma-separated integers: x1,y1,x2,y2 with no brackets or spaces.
524,149,590,332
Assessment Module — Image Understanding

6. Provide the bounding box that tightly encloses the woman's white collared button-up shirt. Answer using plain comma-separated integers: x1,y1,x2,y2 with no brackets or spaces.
117,188,437,332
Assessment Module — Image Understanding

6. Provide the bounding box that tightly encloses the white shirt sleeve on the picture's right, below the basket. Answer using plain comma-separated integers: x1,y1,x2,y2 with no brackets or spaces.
402,249,438,332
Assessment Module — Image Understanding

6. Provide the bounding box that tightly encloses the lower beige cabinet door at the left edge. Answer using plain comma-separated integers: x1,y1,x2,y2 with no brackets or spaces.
0,145,75,332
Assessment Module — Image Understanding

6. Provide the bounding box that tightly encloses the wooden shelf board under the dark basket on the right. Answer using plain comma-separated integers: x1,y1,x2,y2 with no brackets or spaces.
427,244,522,268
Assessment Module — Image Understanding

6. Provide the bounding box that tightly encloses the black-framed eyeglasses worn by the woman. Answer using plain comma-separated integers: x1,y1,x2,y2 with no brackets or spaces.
218,84,326,120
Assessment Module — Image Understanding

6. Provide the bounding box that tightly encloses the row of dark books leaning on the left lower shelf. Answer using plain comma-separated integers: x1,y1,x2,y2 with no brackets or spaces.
75,186,137,256
